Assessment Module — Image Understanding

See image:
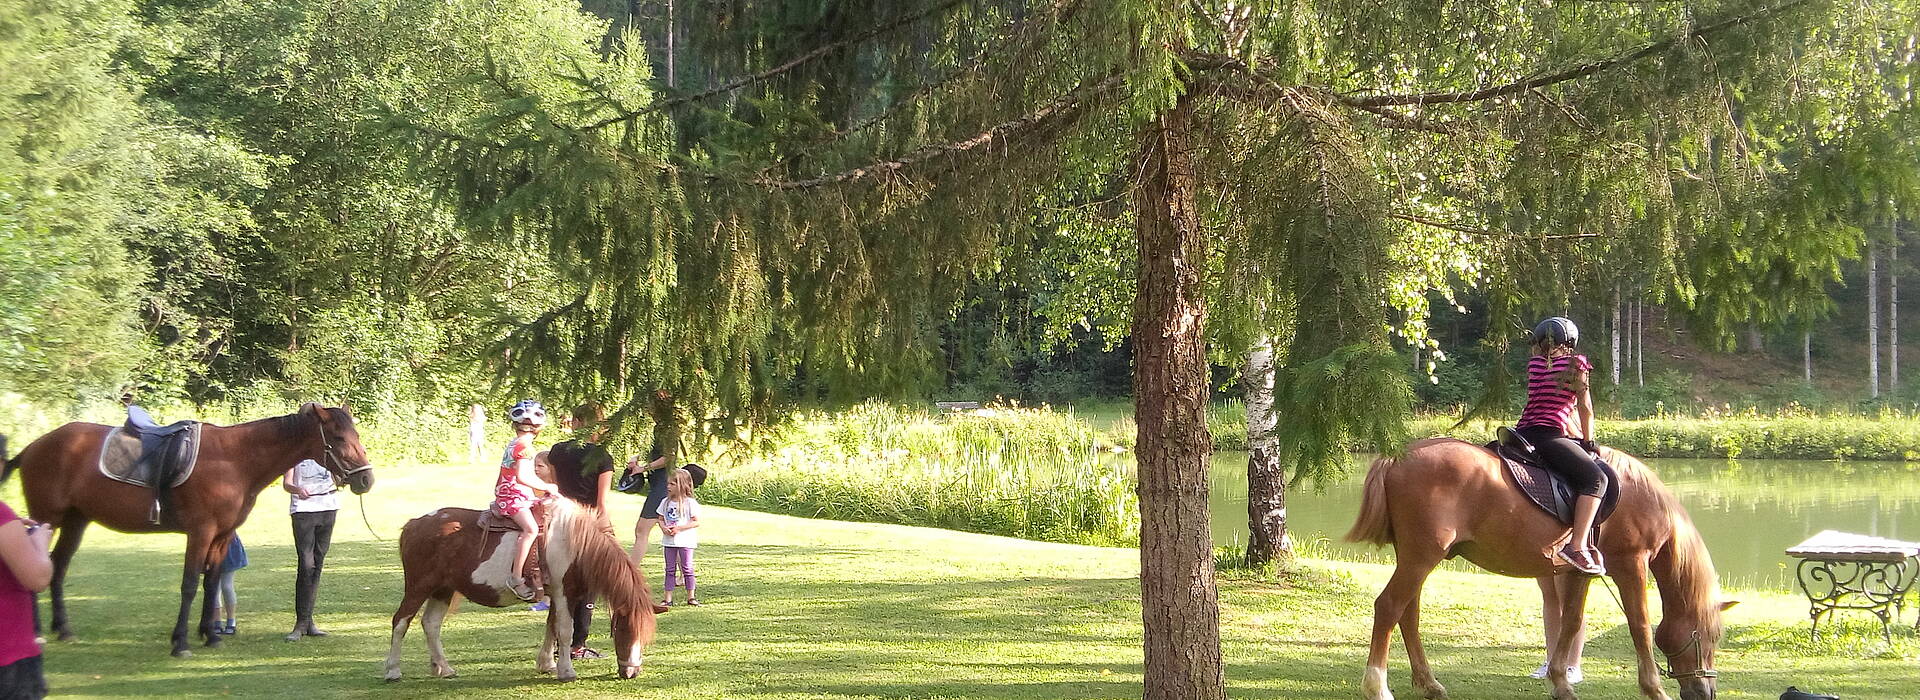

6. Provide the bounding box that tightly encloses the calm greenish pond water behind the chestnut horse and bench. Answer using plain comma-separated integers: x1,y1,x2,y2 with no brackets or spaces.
1212,453,1920,591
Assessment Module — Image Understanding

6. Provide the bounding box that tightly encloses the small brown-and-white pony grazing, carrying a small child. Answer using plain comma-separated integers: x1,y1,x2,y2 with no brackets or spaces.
386,499,655,681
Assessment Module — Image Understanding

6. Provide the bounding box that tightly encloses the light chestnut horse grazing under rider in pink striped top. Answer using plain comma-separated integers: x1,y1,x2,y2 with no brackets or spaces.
1346,439,1732,700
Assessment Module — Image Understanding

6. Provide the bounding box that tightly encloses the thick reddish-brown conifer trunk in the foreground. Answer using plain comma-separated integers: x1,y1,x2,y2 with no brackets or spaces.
1133,98,1225,700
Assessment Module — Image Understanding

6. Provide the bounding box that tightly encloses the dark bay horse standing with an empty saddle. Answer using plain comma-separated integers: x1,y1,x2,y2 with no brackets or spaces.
0,403,372,656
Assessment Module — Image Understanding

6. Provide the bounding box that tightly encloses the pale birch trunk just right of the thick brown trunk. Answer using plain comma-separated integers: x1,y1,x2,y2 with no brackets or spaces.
1240,338,1294,566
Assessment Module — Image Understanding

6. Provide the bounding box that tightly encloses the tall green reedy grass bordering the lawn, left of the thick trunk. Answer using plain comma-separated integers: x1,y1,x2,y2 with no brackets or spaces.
701,403,1140,547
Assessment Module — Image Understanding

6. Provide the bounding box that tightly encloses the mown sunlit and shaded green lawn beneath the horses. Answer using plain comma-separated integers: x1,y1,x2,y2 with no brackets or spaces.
0,454,1920,700
